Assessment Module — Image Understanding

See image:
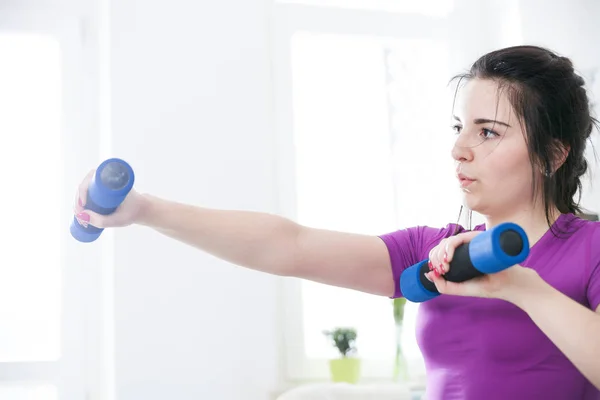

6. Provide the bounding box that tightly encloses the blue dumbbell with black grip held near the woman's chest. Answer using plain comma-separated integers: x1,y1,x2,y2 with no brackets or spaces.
400,222,529,303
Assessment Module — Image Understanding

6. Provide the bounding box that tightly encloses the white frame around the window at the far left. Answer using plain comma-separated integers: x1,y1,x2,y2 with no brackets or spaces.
0,3,106,400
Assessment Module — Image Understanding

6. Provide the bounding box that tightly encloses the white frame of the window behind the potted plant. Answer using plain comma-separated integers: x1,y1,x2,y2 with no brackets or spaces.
271,3,448,383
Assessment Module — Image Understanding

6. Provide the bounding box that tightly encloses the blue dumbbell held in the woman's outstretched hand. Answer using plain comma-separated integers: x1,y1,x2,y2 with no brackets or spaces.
70,158,135,243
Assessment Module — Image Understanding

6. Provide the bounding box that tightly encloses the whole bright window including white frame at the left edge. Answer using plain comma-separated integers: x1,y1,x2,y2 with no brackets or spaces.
0,10,98,400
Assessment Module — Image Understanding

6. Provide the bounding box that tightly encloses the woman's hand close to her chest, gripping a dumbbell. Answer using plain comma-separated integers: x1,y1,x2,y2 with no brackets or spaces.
426,231,539,302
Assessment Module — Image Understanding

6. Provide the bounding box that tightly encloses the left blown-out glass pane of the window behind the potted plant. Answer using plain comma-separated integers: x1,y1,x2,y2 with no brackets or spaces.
292,33,394,366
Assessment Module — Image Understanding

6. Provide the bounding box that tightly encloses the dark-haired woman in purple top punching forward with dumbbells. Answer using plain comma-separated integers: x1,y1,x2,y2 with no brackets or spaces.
75,46,600,400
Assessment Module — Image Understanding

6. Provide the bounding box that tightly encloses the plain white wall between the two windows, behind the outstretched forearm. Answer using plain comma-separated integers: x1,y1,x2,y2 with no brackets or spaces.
110,0,278,400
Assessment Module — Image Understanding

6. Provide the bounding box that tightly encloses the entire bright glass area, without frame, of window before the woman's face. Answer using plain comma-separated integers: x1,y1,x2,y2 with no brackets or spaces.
292,33,460,376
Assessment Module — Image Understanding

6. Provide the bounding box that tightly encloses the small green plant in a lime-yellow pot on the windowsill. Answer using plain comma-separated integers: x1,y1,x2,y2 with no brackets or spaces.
323,327,360,383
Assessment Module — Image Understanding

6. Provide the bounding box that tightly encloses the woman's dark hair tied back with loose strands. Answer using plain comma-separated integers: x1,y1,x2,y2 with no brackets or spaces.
452,46,599,233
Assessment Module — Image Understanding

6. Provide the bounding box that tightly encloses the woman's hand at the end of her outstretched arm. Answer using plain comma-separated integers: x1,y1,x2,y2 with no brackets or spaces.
73,170,147,228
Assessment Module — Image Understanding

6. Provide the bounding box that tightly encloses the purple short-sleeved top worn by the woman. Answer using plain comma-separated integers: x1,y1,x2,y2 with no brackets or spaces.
380,214,600,400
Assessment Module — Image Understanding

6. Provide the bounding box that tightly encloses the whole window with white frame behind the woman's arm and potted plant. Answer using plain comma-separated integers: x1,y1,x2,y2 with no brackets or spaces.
275,0,460,381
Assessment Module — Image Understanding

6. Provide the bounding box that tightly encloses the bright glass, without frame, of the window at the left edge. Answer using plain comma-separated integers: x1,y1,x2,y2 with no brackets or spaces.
0,34,65,360
